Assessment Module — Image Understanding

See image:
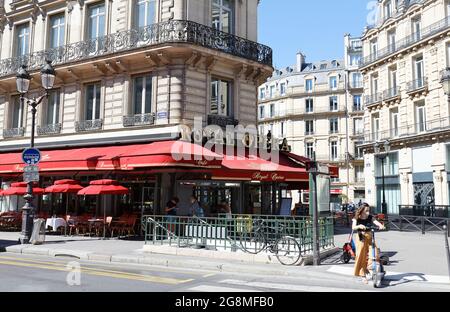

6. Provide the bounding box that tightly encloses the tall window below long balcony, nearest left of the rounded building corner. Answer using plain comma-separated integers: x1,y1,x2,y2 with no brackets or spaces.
133,75,153,115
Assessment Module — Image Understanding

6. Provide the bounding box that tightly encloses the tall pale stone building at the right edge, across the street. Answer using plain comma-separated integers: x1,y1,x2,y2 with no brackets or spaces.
360,0,450,214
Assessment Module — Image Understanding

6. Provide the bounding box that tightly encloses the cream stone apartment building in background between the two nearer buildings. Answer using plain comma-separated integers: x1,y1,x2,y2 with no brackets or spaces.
258,34,365,206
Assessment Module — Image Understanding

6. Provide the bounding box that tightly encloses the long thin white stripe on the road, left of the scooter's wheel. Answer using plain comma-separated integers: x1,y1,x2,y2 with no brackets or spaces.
219,280,367,292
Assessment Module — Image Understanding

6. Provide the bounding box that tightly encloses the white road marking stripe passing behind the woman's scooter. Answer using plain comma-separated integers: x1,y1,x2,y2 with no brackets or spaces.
327,265,450,284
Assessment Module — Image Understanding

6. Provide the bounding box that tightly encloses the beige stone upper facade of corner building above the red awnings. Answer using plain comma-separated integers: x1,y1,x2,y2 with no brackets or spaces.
0,0,272,151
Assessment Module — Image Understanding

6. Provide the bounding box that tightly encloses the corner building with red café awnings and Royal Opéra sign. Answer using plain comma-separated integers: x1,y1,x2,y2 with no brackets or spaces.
0,0,330,222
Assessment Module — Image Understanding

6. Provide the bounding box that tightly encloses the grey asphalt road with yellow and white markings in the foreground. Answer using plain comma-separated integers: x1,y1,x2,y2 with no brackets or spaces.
0,253,450,292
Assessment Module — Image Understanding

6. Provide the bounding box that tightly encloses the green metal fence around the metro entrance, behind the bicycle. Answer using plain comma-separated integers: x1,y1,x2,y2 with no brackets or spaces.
143,215,334,255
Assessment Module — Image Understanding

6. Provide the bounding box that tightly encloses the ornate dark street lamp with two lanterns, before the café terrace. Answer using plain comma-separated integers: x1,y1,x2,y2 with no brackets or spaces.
16,61,56,244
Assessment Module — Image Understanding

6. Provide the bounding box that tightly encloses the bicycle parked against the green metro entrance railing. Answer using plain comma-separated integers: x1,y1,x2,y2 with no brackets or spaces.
240,220,301,266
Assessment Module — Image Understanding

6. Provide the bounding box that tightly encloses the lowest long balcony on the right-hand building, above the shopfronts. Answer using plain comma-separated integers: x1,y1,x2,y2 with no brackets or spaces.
364,117,450,144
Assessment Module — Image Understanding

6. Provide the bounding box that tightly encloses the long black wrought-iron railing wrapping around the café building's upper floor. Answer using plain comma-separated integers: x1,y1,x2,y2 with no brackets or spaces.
0,20,272,77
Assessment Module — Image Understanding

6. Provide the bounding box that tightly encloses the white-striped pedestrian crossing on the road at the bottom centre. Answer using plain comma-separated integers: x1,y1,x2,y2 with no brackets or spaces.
188,279,367,293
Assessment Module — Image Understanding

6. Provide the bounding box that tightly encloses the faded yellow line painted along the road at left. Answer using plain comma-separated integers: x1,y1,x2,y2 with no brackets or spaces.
0,260,193,285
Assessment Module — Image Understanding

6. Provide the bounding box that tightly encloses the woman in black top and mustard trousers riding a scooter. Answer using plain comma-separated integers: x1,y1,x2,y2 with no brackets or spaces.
352,204,384,284
